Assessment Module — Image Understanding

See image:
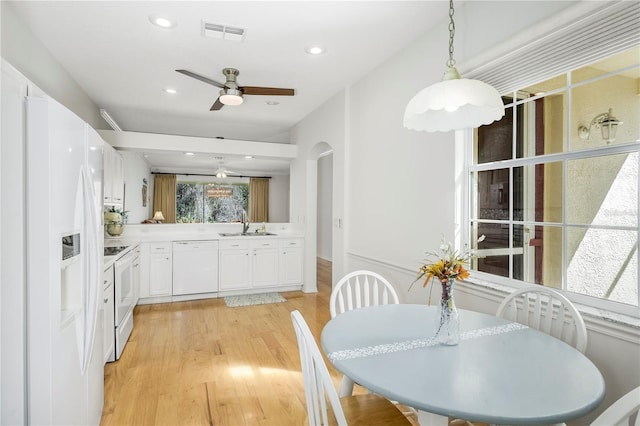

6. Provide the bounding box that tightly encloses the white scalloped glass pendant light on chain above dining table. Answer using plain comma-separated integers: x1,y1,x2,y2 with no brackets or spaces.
404,0,504,132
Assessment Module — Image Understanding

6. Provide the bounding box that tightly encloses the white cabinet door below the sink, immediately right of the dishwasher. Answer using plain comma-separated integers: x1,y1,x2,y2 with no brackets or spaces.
220,240,251,291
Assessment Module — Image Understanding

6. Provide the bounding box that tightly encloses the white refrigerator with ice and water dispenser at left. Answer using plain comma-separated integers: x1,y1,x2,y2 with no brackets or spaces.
25,96,104,425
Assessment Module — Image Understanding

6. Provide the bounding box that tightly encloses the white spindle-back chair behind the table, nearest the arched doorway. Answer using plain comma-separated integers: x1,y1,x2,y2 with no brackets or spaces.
329,271,400,397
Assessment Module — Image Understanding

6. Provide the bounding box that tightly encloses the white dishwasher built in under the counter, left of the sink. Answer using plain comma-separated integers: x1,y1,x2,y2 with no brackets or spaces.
173,241,218,296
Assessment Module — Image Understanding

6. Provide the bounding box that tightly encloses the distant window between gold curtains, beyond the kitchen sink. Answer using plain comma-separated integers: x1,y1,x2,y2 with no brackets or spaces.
176,177,249,223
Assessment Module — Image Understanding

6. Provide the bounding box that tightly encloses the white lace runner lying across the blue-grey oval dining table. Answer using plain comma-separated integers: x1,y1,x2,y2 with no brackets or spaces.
327,323,528,362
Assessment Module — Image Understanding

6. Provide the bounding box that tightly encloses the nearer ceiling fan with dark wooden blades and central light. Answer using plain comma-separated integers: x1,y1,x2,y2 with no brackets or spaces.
176,68,295,111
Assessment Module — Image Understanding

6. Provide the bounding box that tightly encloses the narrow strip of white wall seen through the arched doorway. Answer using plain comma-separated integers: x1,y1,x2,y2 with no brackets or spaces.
318,155,333,261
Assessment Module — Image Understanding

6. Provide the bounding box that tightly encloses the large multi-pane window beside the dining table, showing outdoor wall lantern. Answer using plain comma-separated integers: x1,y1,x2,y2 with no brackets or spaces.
468,46,640,311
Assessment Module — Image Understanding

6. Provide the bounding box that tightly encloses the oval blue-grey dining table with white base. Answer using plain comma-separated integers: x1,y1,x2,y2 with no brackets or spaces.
321,304,605,425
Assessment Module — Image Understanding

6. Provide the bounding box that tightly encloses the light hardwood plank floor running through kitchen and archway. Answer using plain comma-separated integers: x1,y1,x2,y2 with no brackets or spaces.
101,260,340,426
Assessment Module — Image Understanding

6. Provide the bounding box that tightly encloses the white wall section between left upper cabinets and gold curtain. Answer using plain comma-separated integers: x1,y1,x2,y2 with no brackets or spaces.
119,151,153,224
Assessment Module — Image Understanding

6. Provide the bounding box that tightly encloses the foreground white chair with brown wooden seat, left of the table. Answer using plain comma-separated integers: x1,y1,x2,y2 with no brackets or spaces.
291,311,411,426
